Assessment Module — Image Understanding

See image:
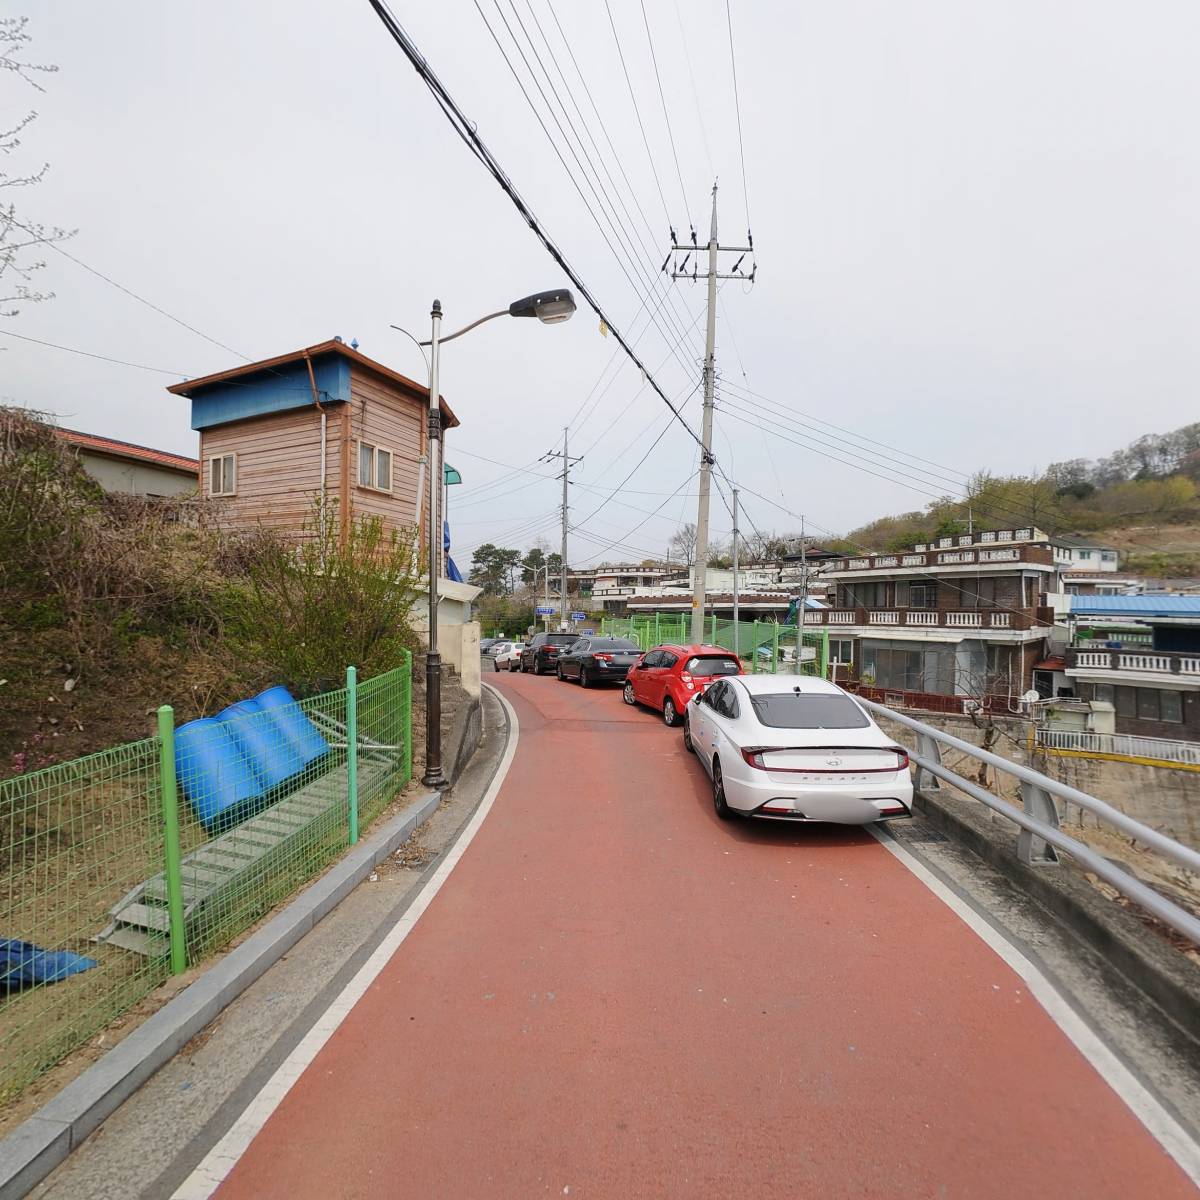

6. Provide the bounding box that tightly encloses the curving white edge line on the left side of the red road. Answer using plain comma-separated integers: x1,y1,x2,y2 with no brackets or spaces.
172,684,521,1200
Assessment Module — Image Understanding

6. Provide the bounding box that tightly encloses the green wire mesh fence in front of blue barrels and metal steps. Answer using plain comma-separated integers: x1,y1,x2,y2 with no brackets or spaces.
0,659,413,1102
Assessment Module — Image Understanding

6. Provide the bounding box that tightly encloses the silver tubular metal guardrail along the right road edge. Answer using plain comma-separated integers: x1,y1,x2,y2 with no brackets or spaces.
857,696,1200,946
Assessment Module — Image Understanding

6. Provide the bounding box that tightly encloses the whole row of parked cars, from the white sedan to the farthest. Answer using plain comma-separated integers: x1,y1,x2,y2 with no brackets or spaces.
497,634,913,824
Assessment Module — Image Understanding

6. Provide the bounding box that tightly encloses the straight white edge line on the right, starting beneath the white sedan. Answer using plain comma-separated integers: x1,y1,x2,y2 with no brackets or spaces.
866,826,1200,1186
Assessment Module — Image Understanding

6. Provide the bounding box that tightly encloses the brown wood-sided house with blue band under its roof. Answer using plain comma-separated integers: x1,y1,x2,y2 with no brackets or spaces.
167,338,458,556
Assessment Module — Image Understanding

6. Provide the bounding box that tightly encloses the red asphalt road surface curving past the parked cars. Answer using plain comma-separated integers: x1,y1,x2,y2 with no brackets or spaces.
218,674,1195,1200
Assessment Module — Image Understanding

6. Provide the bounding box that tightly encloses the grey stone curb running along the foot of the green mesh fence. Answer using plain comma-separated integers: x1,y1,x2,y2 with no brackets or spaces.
0,787,441,1200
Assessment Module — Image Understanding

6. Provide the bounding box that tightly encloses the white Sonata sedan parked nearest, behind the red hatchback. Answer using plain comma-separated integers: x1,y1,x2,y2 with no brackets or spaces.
683,676,912,824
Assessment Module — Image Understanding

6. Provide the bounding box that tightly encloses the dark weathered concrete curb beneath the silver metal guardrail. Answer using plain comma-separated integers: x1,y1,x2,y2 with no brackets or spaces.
917,790,1200,1066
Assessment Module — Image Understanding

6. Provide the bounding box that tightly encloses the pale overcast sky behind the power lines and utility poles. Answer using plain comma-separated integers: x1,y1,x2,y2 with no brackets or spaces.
0,0,1200,562
